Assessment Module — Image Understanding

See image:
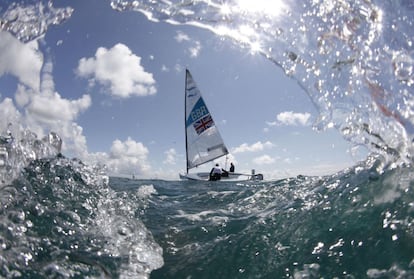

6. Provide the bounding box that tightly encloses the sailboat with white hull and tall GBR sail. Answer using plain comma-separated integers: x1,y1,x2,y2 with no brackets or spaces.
180,69,263,181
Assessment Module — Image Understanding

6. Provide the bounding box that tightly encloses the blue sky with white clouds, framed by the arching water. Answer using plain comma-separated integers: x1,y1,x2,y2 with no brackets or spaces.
0,0,361,179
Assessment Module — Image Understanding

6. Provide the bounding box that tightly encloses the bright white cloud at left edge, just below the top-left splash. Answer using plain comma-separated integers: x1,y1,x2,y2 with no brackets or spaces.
0,31,43,91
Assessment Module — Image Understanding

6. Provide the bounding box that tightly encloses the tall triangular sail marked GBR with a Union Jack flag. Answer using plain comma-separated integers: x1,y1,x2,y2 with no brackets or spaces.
185,70,229,173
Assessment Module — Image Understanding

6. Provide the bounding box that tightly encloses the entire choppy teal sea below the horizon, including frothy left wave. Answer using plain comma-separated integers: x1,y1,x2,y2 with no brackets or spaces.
0,155,414,278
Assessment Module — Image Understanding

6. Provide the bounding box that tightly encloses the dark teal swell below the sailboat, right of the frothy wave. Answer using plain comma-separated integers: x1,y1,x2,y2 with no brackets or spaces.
141,165,414,278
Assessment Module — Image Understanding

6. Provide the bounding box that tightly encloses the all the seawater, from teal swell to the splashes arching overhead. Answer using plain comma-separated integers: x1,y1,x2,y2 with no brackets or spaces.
0,0,414,278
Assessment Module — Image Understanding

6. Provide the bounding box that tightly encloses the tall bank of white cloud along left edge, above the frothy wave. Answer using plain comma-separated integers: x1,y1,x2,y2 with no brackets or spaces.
0,32,91,160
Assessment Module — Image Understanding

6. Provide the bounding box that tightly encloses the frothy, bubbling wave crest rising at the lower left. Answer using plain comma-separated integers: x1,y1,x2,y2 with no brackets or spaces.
0,155,163,278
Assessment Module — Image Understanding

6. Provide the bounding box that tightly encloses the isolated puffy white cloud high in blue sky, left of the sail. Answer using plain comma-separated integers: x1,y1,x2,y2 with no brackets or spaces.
76,44,156,98
